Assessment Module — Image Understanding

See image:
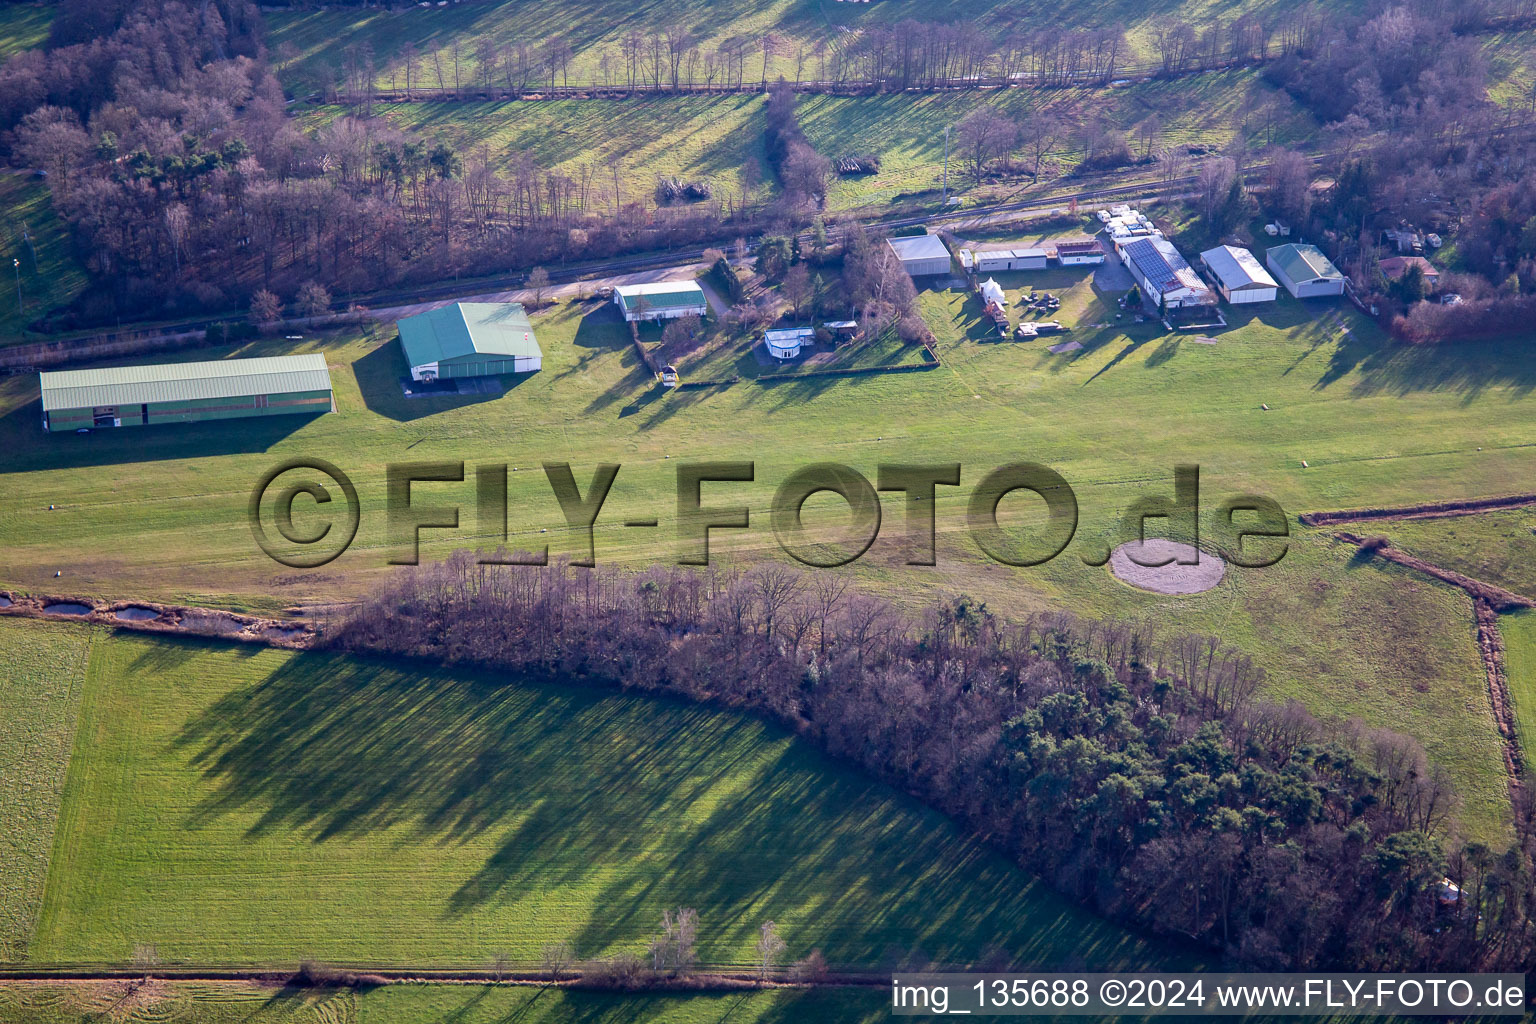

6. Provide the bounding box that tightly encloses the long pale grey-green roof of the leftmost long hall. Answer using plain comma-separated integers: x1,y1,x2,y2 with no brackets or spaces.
41,353,330,411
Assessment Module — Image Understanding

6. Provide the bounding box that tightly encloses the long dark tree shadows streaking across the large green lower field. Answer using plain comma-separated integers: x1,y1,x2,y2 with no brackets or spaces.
174,654,1146,967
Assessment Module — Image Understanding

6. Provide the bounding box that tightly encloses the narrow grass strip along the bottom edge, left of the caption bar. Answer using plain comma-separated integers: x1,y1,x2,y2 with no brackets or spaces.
0,983,891,1024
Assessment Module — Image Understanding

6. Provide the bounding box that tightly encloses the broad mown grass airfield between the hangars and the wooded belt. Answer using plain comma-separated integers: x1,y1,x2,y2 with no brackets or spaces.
0,276,1536,838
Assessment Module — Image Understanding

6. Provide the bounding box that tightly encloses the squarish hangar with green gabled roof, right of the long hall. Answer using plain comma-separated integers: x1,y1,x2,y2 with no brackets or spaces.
398,302,544,381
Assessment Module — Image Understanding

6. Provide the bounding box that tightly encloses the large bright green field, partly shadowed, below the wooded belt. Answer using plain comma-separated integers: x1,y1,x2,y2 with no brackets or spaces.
29,634,1178,969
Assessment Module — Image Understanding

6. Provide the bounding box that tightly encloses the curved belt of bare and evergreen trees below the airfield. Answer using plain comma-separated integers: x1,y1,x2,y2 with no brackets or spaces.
329,553,1536,970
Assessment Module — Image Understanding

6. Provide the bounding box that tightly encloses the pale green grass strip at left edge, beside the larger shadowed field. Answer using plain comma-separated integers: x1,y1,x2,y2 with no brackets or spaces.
0,620,92,964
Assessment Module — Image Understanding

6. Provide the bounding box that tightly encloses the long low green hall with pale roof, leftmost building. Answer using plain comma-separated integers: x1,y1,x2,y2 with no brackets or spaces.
41,355,336,433
